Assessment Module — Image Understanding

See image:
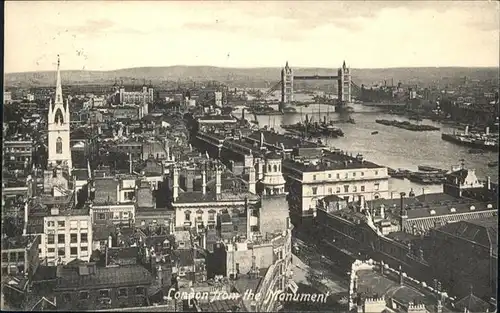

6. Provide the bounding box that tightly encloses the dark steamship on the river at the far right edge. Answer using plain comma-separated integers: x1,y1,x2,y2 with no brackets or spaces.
441,126,498,151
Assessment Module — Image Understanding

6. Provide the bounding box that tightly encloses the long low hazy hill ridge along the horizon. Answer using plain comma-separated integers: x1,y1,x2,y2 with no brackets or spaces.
4,66,498,87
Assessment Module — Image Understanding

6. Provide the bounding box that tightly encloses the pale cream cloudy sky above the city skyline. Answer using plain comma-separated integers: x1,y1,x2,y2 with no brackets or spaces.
4,1,500,73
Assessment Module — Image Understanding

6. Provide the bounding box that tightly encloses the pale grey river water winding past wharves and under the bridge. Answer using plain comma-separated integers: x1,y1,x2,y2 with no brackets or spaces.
233,104,498,194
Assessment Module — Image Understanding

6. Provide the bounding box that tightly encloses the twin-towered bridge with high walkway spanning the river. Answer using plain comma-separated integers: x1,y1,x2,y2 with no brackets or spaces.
264,61,359,108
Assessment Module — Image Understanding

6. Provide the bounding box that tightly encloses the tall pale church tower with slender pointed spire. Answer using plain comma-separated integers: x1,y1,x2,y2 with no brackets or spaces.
47,56,72,174
